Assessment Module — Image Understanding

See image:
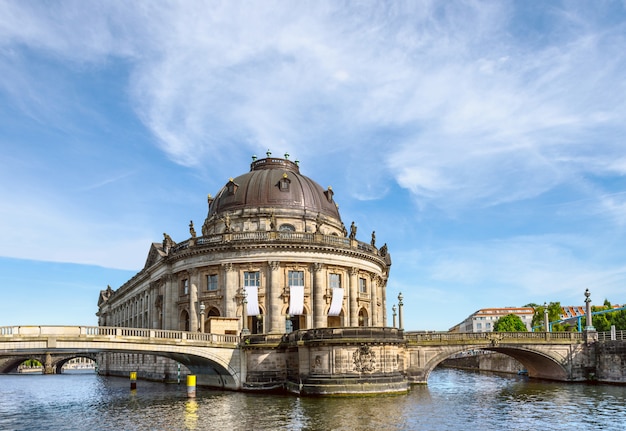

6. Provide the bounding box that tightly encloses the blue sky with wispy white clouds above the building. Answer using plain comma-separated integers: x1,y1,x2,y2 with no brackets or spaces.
0,0,626,330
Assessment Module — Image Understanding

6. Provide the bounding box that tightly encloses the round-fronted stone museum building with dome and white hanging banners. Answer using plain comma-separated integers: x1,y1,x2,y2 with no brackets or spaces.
97,152,391,340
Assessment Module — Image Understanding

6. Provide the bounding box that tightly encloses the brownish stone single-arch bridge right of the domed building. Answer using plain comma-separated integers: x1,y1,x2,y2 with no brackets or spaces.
404,332,597,383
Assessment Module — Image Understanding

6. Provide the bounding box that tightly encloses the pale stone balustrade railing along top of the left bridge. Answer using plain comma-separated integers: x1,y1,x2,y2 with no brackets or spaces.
0,326,239,345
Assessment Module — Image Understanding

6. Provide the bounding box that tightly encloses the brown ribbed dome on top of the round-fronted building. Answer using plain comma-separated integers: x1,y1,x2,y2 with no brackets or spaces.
203,154,345,234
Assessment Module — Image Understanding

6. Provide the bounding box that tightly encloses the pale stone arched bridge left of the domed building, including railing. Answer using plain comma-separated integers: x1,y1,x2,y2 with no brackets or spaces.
0,326,245,390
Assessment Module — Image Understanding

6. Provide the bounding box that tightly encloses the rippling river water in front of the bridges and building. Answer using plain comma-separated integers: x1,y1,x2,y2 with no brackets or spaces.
0,369,626,431
